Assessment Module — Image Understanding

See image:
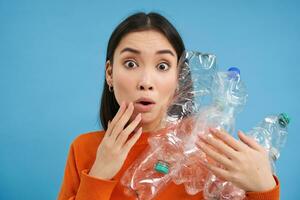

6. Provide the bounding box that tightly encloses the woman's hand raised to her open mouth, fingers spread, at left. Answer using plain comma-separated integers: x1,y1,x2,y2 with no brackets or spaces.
89,102,142,180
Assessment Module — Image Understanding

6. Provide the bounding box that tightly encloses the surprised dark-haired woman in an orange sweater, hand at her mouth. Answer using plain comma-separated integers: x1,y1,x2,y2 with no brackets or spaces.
58,13,279,200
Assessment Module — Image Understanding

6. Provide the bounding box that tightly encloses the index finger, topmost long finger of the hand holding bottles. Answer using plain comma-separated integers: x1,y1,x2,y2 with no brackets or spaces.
209,128,244,151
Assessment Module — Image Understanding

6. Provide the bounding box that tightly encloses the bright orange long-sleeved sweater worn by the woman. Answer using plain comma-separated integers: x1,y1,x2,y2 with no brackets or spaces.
58,131,279,200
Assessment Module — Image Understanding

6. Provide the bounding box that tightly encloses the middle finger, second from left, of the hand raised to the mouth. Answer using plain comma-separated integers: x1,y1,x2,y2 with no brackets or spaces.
111,102,134,141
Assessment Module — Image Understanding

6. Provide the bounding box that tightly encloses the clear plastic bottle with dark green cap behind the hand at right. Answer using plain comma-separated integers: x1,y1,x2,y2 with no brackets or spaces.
204,113,290,200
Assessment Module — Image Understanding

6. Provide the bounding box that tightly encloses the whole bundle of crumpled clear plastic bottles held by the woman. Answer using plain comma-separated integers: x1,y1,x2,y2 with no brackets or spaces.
121,48,285,200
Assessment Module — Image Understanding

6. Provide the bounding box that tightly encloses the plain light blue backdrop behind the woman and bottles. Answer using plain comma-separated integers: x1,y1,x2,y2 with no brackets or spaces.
0,0,300,200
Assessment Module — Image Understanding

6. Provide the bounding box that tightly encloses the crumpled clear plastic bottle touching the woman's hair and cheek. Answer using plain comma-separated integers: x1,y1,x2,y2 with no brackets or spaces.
163,51,217,123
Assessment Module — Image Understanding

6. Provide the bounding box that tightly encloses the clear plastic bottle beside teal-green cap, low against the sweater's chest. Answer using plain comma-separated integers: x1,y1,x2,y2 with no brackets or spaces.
121,126,182,200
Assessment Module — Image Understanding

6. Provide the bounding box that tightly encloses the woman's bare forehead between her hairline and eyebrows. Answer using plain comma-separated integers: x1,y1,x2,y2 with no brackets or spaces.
116,30,176,55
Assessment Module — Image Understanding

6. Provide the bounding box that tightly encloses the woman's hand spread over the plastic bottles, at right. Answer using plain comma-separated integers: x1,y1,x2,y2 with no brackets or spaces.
197,129,276,192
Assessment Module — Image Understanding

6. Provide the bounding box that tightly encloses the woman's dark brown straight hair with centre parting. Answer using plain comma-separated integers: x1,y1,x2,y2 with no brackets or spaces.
99,12,185,130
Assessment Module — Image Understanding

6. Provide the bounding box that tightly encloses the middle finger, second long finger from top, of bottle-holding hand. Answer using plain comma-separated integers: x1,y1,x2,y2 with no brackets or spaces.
199,135,237,159
